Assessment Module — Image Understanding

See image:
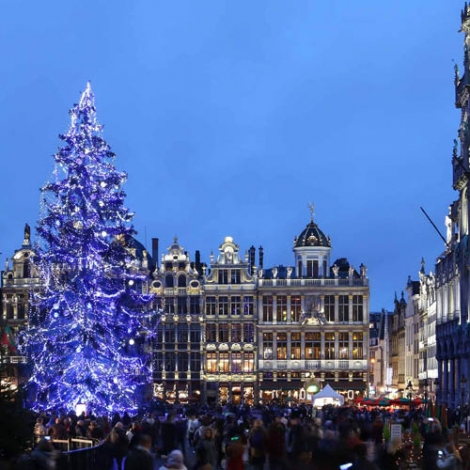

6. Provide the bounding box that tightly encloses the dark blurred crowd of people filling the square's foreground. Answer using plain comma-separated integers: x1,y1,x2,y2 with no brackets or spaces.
23,405,470,470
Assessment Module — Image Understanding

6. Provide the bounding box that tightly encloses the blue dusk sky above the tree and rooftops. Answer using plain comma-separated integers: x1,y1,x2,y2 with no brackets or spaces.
0,0,464,311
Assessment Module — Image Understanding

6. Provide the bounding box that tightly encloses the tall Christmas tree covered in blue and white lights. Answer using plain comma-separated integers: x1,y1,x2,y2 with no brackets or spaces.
21,84,152,414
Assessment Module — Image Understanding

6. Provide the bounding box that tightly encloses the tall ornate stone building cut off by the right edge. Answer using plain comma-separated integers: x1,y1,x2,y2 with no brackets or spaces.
436,4,470,407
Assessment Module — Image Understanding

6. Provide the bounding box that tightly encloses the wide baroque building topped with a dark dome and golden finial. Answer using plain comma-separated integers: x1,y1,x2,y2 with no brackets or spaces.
257,210,370,400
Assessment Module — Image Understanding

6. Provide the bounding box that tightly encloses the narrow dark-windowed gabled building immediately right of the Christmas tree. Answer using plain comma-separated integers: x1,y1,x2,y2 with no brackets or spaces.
150,237,205,403
